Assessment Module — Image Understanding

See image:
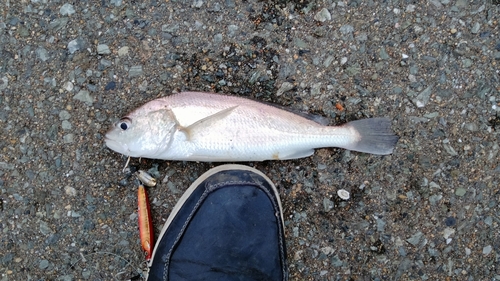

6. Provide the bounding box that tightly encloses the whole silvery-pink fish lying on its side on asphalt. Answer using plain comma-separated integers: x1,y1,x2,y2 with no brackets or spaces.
105,92,399,162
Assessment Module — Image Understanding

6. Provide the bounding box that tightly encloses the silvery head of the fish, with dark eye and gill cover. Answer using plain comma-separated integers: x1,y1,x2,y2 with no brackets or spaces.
105,101,177,159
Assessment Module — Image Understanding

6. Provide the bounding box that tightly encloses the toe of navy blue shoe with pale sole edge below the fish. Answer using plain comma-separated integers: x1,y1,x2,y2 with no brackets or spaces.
147,165,288,281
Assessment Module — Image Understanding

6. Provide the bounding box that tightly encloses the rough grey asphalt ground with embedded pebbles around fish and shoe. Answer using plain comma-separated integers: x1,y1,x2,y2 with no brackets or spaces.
0,0,500,281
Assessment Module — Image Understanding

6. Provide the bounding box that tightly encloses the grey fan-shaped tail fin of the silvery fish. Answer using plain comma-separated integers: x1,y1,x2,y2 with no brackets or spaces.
343,118,399,155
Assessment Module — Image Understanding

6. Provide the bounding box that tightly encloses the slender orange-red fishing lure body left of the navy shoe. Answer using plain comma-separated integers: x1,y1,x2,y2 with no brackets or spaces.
137,184,154,261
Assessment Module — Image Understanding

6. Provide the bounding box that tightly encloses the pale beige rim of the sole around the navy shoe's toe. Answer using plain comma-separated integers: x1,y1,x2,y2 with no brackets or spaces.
148,164,285,267
